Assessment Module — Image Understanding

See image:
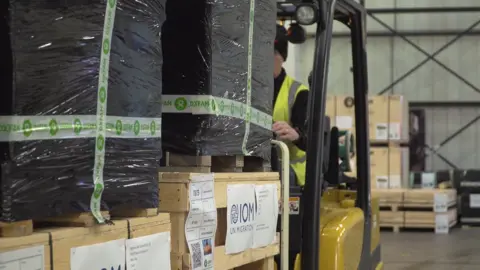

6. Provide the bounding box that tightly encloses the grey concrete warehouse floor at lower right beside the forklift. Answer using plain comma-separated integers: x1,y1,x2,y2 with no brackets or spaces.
381,228,480,270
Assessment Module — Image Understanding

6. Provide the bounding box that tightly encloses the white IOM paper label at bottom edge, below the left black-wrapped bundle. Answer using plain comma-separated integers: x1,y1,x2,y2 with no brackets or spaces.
70,239,125,270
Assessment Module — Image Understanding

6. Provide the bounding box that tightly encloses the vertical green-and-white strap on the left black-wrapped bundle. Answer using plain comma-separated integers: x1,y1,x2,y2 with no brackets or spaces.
90,0,117,223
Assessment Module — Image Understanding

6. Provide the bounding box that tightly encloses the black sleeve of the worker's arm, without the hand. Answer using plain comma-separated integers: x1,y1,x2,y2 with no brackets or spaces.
290,90,308,151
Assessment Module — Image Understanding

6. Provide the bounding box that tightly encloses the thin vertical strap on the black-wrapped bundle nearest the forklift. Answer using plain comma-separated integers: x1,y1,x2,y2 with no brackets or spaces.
242,0,255,156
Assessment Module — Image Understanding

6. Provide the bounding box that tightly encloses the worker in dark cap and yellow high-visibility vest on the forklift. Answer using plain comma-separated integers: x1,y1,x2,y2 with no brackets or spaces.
272,24,308,186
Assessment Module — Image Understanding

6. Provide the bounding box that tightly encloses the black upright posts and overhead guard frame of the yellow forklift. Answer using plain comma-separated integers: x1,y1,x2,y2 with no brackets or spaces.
277,0,371,270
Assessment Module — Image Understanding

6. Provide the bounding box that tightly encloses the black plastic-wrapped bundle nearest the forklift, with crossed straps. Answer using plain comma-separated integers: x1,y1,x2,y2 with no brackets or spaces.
162,0,276,159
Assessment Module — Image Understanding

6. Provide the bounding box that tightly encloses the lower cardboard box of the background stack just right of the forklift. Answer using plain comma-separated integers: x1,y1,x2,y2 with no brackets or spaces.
370,147,409,189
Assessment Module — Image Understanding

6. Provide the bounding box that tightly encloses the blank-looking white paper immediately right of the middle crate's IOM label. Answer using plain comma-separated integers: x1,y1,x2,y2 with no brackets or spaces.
253,184,278,248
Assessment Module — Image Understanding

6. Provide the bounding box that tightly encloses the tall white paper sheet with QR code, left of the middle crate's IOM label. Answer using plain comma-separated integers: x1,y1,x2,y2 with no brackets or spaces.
185,174,217,270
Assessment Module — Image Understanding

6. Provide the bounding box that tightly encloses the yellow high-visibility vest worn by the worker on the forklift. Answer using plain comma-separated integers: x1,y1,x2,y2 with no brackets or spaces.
273,76,308,186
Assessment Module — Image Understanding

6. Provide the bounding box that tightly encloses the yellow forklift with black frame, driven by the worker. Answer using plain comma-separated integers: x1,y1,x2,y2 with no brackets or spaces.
273,0,383,270
